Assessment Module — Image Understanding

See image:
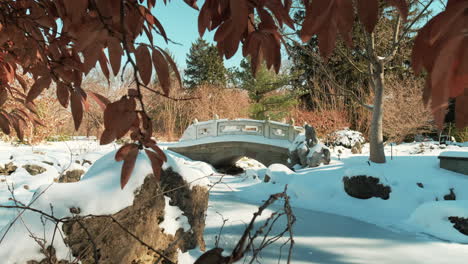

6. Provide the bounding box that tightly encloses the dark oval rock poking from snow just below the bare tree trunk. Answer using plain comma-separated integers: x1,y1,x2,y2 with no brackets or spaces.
343,175,392,200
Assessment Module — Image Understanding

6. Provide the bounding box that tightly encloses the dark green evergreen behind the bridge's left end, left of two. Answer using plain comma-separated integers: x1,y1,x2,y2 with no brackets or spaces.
184,38,227,88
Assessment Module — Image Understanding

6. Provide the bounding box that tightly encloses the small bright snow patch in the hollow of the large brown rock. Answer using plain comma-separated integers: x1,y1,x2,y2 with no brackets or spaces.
159,196,190,236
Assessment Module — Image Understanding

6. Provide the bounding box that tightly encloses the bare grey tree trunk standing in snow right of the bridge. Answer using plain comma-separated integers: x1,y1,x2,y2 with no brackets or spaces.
369,62,385,163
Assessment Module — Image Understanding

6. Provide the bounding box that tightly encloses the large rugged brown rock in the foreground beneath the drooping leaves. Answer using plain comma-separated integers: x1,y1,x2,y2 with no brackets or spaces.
63,169,208,264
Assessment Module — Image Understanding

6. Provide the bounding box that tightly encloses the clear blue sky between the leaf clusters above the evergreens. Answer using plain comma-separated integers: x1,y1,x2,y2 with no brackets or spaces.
152,0,242,70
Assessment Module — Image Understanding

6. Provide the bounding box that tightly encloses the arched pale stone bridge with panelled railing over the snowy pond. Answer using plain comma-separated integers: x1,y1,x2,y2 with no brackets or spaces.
168,119,303,167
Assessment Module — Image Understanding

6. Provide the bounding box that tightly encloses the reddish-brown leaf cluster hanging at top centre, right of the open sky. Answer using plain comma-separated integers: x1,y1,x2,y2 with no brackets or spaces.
198,0,294,72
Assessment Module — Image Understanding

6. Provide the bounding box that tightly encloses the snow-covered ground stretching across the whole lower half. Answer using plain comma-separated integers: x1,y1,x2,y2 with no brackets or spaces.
0,140,468,264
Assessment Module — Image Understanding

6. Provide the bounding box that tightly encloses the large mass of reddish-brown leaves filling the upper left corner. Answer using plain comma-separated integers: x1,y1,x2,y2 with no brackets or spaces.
0,0,180,190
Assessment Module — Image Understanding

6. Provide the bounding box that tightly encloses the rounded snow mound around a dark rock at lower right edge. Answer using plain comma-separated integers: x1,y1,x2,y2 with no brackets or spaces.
408,200,468,243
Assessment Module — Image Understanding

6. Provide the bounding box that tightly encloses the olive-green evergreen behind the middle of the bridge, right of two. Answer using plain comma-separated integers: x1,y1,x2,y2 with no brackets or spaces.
232,59,296,120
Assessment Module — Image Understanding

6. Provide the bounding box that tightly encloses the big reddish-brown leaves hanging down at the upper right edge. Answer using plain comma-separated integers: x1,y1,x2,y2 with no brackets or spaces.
412,0,468,127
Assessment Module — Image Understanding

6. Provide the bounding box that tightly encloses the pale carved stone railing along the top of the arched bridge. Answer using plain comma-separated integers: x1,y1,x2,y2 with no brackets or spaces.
180,119,304,142
